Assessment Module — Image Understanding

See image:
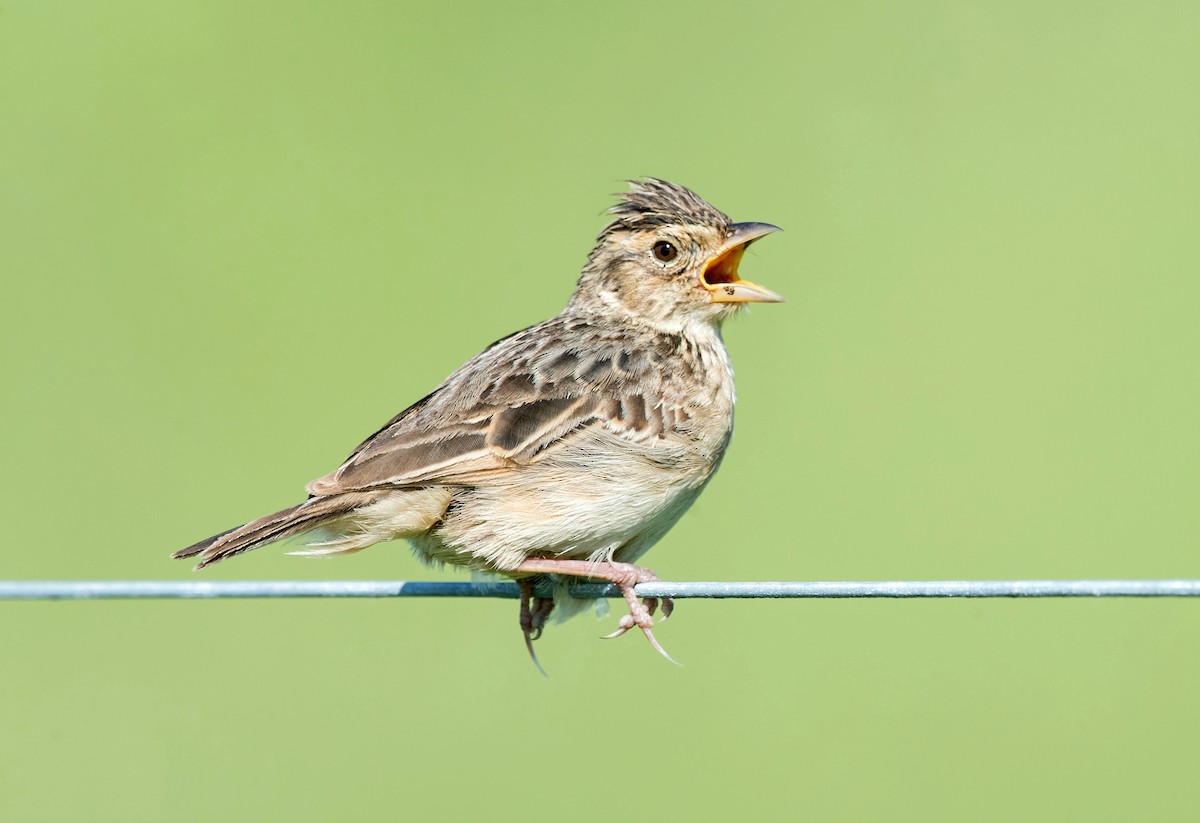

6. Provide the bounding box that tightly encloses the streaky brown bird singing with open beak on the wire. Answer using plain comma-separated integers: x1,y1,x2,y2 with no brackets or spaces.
173,178,784,673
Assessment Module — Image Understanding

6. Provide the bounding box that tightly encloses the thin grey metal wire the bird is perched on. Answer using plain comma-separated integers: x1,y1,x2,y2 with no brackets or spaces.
0,579,1200,600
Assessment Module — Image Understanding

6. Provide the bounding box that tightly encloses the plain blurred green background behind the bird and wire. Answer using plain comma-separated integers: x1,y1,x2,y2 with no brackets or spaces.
0,0,1200,821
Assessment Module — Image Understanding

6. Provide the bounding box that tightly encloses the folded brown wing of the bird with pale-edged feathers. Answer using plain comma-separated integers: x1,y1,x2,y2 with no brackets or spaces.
308,320,674,495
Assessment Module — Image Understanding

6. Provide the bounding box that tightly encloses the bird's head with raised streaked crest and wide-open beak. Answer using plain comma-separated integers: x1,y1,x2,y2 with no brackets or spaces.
571,178,784,328
